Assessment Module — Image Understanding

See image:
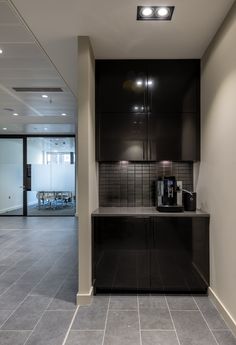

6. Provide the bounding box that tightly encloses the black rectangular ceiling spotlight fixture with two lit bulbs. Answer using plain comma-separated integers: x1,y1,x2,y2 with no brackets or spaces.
137,6,175,20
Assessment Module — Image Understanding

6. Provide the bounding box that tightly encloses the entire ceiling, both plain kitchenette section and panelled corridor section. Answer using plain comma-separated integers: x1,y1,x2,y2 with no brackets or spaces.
0,0,234,134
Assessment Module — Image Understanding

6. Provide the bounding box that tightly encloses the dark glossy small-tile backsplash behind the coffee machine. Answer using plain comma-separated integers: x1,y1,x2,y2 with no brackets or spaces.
99,162,193,207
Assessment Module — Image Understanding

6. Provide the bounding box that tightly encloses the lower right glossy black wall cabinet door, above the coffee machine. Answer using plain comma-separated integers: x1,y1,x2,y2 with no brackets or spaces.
148,113,200,161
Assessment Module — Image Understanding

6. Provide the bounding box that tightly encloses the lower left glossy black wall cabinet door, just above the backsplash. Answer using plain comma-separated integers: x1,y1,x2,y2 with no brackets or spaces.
96,113,148,161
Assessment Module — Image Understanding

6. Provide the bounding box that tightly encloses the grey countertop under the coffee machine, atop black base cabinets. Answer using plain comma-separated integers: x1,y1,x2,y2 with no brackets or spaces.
92,207,210,217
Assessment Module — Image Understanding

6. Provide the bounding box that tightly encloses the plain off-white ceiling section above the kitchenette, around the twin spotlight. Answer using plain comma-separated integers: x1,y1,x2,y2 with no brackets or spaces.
8,0,234,94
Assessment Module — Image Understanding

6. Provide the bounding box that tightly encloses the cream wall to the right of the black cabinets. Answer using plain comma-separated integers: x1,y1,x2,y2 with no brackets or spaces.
197,4,236,326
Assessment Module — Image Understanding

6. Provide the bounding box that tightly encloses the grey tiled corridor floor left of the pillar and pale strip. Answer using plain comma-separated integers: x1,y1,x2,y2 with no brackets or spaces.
0,217,77,345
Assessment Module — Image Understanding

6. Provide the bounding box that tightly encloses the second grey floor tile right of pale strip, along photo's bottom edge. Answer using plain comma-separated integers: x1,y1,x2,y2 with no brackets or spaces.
104,331,141,345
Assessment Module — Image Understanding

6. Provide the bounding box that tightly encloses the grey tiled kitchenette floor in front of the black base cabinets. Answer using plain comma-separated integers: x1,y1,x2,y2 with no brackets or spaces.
66,295,236,345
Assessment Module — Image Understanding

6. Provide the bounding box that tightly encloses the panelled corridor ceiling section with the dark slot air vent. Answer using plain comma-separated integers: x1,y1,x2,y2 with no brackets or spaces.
0,1,77,134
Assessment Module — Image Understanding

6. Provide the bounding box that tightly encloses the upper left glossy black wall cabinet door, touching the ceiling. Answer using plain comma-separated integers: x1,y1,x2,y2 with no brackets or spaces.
96,60,147,113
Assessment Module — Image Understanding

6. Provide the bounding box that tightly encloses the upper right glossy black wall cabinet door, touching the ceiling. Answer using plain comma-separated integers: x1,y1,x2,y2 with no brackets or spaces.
148,60,200,114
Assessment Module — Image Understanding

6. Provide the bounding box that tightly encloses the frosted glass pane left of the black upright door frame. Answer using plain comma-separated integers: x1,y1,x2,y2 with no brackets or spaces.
0,138,24,216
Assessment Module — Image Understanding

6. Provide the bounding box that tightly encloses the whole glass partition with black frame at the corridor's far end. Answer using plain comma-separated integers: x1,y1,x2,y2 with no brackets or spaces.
0,136,75,216
